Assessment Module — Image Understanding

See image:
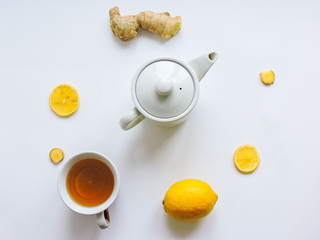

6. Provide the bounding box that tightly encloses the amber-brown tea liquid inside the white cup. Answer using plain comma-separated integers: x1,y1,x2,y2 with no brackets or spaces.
66,158,114,207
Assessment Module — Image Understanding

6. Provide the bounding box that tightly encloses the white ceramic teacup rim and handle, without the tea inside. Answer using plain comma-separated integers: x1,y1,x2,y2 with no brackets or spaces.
58,152,120,228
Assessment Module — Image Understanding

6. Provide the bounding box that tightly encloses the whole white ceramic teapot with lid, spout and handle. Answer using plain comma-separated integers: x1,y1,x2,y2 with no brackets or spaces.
120,52,218,130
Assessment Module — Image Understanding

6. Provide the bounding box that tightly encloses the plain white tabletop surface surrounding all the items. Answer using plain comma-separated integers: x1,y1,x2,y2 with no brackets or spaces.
0,0,320,240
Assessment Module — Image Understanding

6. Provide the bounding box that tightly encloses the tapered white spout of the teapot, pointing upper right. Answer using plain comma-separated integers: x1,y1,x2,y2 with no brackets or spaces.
188,52,218,81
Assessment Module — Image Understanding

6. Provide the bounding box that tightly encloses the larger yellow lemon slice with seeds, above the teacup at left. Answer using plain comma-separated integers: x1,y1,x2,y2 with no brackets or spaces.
49,83,80,117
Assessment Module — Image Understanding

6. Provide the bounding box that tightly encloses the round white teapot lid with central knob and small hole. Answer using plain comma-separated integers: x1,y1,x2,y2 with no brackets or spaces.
132,58,198,121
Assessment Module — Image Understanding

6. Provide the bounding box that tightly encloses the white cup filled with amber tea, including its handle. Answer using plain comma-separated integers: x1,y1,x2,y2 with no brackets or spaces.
58,152,120,228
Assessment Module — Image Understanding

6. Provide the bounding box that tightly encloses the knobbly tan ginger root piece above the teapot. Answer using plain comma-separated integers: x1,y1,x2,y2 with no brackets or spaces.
109,7,181,42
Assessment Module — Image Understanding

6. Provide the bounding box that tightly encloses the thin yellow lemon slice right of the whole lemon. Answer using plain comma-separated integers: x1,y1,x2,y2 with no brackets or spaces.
233,144,260,173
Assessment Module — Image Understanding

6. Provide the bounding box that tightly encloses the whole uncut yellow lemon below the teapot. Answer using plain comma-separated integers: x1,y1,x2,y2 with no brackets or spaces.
162,179,218,221
